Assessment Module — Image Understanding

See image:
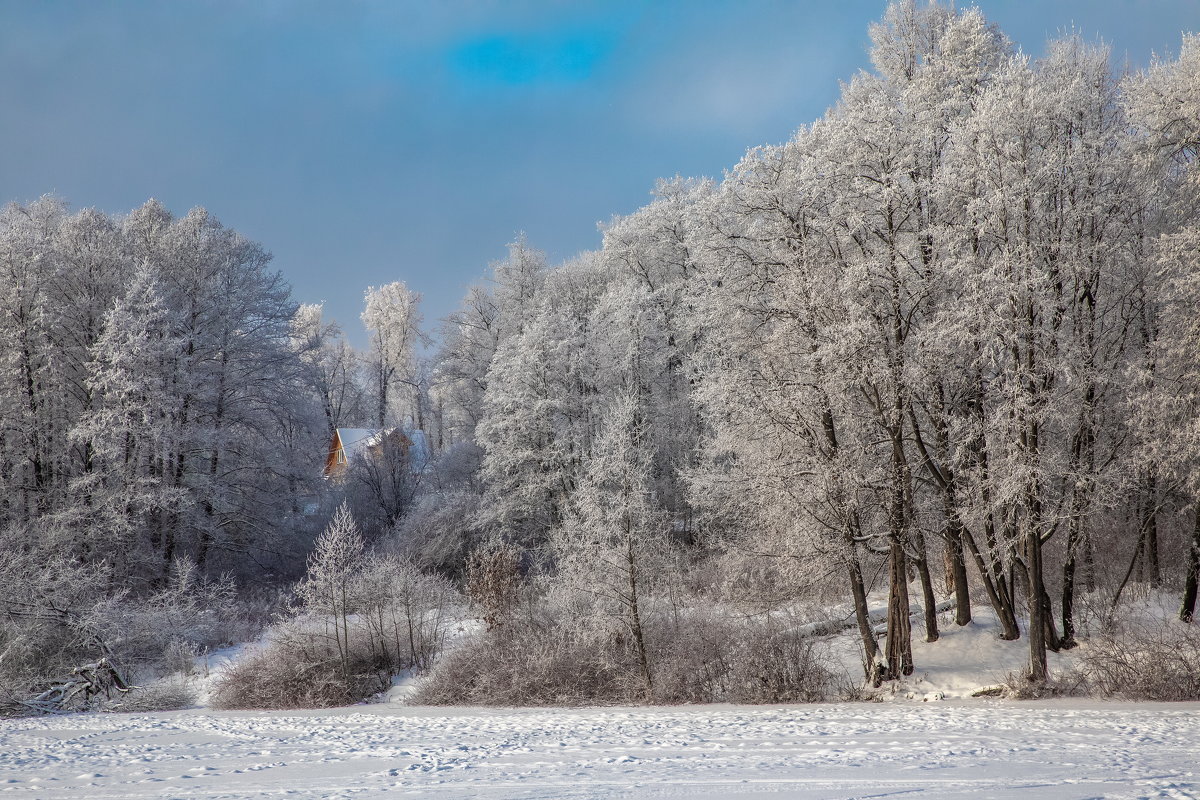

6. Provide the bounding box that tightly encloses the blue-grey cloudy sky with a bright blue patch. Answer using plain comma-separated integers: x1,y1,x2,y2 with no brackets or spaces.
0,0,1200,344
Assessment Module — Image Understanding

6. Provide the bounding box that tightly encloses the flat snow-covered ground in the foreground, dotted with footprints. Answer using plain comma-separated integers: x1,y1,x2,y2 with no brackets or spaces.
0,700,1200,800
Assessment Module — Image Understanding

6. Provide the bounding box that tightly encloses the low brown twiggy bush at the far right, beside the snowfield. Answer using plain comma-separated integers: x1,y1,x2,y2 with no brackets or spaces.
1080,621,1200,700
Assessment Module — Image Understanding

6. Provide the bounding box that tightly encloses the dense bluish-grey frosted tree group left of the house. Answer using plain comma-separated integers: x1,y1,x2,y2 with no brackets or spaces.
0,199,324,581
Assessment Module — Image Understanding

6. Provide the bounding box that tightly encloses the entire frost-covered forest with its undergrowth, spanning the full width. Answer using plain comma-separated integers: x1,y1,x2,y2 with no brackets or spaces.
0,0,1200,714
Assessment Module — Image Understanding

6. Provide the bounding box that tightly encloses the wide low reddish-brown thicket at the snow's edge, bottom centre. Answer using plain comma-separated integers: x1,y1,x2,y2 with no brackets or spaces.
413,603,833,705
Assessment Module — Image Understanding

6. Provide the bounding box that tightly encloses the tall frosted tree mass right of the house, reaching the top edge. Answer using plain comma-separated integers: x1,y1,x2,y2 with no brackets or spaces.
398,2,1200,682
